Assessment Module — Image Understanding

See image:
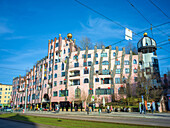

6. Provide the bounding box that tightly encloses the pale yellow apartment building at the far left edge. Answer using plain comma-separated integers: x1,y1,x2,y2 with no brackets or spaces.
0,83,12,108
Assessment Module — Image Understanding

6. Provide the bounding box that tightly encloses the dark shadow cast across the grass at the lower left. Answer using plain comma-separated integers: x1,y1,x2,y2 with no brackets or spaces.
4,114,38,128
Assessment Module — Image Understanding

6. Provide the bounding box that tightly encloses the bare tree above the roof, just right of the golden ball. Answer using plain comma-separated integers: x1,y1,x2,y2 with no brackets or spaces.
80,37,93,50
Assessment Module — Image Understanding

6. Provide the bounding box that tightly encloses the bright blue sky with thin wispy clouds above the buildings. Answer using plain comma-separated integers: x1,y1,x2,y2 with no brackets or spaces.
0,0,170,84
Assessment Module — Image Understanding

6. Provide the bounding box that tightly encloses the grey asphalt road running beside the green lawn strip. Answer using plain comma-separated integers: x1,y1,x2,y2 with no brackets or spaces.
23,113,170,127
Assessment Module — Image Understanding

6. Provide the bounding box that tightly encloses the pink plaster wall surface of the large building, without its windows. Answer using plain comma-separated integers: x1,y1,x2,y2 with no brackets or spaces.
12,37,138,105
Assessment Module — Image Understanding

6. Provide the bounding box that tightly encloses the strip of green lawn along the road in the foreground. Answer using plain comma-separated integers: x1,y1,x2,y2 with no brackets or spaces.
0,113,161,128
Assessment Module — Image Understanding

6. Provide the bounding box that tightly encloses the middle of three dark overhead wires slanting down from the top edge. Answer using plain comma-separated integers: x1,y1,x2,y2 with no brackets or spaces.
127,0,169,36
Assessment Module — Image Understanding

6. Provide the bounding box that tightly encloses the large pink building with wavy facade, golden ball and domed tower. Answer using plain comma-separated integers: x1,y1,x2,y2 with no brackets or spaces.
12,33,159,109
